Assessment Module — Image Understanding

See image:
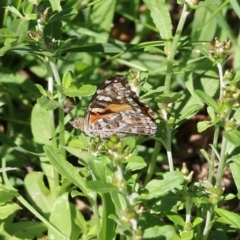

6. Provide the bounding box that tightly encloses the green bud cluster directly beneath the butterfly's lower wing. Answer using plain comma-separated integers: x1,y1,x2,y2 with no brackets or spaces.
106,135,130,164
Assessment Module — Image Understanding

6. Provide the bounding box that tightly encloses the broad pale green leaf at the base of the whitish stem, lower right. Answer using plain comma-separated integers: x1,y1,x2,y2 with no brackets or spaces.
140,171,184,199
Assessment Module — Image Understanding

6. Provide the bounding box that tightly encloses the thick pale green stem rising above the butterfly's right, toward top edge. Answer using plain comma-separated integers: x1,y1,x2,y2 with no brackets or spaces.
164,4,189,93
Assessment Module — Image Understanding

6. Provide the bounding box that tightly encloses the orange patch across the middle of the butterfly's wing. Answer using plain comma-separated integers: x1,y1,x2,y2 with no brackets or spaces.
89,103,133,124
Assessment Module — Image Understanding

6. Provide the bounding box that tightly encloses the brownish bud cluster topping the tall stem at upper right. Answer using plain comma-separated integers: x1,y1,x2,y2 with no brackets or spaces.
211,37,232,60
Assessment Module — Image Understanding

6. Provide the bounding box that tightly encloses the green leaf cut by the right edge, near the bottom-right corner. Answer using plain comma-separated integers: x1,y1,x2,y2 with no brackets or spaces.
214,208,240,229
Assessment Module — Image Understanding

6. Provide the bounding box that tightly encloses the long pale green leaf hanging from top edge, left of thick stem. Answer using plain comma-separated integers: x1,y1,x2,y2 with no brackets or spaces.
144,0,173,49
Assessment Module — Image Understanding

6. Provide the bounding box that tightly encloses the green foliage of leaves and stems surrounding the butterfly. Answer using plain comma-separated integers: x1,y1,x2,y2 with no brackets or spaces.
0,0,240,240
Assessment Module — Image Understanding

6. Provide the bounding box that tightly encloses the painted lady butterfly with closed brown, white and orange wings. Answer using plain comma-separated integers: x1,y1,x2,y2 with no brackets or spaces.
70,75,157,138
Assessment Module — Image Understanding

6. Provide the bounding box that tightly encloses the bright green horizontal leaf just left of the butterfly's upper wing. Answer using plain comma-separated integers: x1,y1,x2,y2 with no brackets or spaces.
64,84,97,97
